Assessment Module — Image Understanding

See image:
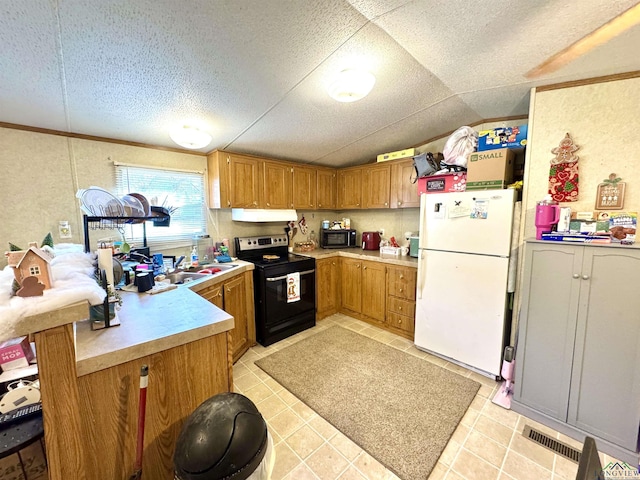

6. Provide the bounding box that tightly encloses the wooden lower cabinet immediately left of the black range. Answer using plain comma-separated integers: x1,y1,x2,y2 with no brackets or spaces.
198,272,256,363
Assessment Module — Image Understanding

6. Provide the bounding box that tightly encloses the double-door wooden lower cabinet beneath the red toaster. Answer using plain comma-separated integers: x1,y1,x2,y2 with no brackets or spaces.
341,258,385,324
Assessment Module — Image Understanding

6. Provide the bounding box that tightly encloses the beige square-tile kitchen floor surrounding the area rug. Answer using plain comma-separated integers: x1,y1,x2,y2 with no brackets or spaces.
233,314,624,480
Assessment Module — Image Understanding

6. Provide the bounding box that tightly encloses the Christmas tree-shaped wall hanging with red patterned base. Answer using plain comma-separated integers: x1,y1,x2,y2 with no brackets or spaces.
549,133,580,202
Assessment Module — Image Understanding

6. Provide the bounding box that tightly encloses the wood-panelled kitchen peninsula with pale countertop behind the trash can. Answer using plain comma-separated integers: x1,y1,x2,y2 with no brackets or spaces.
16,287,240,480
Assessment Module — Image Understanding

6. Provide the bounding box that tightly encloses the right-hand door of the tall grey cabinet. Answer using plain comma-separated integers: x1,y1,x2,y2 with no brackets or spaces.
568,247,640,451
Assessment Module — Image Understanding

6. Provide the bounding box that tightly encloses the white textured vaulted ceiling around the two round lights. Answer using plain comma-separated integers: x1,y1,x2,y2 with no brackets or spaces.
0,0,640,166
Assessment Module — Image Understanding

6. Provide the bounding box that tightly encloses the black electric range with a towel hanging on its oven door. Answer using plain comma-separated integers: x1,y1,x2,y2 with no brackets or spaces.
234,235,316,346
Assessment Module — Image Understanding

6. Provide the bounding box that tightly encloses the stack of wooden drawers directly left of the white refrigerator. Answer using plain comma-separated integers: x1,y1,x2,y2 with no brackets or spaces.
386,266,417,340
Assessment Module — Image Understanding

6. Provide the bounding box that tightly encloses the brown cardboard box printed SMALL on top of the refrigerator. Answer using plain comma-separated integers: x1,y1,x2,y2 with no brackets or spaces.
467,148,514,190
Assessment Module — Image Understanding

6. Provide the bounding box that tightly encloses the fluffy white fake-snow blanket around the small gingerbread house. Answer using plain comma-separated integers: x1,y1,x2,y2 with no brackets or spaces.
0,243,106,341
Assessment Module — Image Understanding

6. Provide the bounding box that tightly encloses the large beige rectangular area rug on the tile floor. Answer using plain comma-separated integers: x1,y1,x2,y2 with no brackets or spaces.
255,326,480,480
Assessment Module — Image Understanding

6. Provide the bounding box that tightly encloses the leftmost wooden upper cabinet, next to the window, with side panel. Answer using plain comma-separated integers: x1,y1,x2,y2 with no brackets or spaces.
207,150,262,208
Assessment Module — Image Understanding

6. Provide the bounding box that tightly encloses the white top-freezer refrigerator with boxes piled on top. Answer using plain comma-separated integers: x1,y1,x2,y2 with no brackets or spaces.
415,189,517,378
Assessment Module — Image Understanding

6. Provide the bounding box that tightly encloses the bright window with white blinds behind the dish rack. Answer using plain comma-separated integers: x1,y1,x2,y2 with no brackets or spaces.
116,164,206,250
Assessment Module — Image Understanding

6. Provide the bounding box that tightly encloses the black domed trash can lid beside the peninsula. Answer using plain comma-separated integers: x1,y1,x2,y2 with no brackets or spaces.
173,393,267,480
